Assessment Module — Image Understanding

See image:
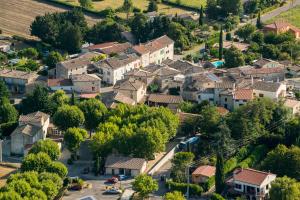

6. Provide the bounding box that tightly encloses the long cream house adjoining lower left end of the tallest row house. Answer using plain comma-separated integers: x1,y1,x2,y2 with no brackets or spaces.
94,54,141,85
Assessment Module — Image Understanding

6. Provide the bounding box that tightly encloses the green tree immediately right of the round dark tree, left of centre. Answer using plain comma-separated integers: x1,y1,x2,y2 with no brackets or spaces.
79,99,107,136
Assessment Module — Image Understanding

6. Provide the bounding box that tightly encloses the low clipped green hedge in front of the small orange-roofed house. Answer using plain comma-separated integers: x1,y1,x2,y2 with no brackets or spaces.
166,181,203,196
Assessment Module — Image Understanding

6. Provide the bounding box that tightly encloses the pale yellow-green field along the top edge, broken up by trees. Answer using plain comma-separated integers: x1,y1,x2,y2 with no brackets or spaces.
59,0,190,14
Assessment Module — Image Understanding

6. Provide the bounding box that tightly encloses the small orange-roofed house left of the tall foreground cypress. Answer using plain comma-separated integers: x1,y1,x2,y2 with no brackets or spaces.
192,165,216,184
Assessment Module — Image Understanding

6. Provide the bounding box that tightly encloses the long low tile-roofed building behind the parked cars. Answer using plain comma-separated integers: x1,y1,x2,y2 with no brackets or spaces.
104,155,147,176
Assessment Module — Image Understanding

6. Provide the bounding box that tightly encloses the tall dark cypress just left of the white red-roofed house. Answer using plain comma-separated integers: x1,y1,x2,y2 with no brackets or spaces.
215,150,225,194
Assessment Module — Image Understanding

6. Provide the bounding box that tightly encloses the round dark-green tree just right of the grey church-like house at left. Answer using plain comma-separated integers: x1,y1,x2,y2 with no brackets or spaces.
53,105,84,131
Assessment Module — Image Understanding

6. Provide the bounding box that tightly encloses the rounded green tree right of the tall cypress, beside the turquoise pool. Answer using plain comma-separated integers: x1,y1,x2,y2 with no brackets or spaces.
224,46,245,68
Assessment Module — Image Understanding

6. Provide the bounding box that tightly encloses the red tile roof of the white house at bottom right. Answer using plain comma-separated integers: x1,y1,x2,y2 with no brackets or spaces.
233,168,276,186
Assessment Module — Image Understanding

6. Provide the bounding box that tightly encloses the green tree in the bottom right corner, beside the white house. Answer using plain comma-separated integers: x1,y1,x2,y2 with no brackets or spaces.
270,176,300,200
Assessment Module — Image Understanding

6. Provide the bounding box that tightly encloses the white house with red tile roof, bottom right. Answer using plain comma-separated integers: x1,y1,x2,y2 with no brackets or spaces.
227,168,276,200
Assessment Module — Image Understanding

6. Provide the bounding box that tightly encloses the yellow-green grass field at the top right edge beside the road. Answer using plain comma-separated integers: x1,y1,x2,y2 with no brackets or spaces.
266,6,300,28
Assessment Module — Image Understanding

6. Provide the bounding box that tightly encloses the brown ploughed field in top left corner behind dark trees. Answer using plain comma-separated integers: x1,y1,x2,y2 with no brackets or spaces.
0,0,101,38
